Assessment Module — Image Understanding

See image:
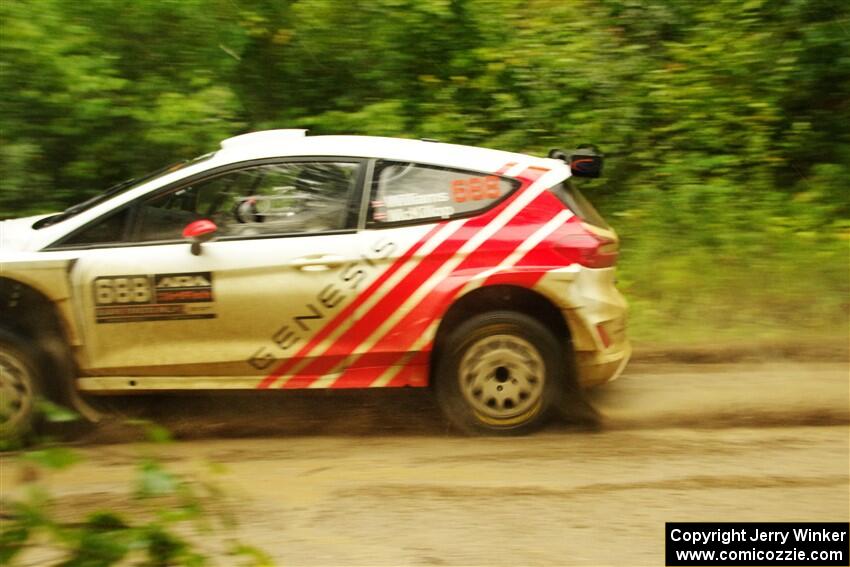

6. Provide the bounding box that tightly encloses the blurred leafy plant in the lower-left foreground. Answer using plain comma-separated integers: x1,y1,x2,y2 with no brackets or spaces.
0,422,271,567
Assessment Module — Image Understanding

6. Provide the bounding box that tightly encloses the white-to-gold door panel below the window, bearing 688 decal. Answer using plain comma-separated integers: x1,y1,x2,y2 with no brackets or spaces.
71,234,363,375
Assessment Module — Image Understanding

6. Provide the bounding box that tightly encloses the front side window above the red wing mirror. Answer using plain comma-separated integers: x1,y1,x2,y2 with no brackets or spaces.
134,161,360,242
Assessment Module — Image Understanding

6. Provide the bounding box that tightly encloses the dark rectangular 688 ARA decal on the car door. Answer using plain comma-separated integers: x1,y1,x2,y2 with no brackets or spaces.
92,272,216,323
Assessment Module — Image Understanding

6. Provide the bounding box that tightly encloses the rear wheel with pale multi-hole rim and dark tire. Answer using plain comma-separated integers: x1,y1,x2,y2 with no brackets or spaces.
434,311,567,435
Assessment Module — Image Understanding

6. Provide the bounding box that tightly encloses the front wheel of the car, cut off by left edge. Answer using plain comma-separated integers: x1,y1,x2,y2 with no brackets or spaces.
0,329,43,442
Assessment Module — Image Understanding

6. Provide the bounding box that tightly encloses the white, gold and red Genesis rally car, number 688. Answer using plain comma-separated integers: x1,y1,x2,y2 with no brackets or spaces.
0,130,630,435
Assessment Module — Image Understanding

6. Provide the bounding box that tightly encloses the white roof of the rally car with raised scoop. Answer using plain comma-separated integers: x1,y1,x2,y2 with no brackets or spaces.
218,130,563,171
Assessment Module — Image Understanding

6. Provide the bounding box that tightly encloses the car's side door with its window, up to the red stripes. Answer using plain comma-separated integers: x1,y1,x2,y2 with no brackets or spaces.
66,158,366,376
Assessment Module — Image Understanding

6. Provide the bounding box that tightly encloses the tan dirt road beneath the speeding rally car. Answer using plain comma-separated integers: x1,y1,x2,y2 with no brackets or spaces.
2,362,850,566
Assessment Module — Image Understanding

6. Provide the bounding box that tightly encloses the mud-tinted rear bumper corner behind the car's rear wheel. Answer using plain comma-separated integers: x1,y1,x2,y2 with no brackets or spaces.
540,265,632,388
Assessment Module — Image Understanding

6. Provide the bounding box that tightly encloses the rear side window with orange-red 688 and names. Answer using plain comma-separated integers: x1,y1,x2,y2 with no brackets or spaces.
368,161,519,227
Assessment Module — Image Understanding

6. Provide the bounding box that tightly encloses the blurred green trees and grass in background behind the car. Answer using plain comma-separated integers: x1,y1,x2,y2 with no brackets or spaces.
0,0,850,338
